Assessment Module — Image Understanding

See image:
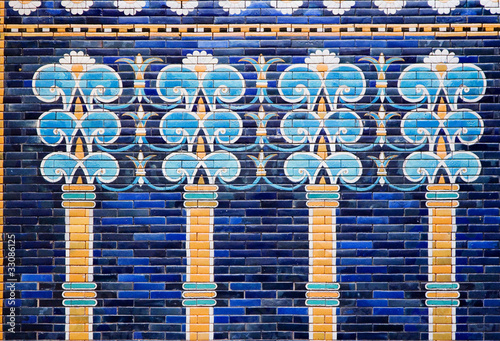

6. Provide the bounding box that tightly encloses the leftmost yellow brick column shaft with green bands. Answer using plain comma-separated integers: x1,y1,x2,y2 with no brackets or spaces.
62,184,97,341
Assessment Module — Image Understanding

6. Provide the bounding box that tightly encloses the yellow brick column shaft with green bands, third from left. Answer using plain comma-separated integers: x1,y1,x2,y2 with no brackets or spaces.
306,185,340,340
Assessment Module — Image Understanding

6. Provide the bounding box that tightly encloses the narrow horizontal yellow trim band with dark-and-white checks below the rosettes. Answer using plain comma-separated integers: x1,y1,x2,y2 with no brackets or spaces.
0,23,500,37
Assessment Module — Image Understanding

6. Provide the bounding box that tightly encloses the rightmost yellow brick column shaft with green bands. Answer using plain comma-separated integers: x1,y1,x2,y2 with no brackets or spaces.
425,184,460,341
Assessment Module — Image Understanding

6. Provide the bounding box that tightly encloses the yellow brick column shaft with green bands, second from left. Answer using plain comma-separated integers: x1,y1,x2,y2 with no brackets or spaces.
182,185,218,340
